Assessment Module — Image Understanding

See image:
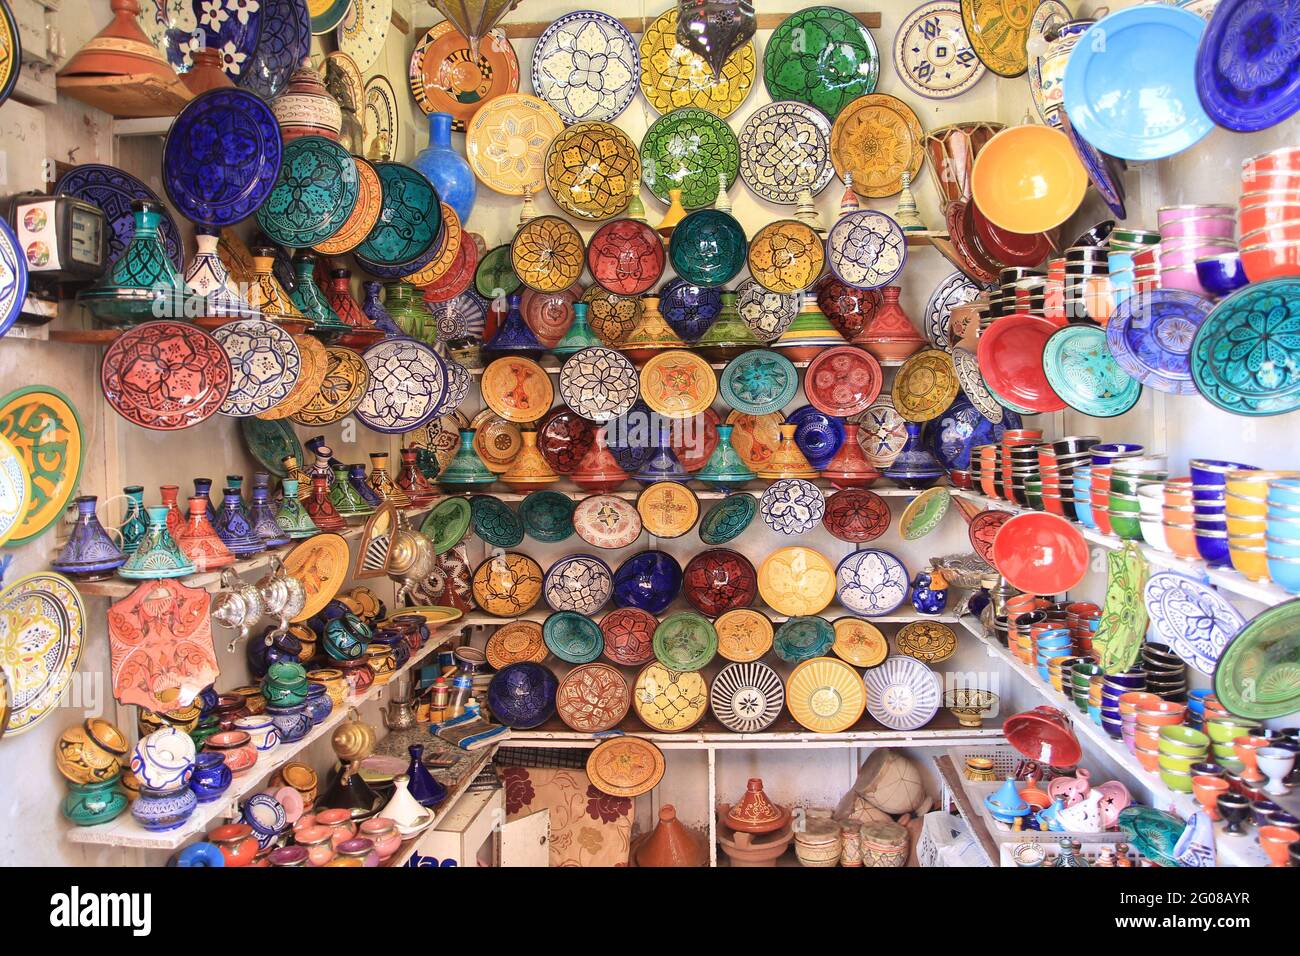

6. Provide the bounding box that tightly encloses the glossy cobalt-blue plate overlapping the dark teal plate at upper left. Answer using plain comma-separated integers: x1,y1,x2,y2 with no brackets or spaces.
163,88,281,226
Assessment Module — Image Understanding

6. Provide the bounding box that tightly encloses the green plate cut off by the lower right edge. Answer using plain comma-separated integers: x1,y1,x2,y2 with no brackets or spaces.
1214,598,1300,721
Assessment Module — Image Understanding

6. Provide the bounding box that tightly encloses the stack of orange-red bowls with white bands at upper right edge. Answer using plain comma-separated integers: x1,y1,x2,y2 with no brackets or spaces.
1238,146,1300,282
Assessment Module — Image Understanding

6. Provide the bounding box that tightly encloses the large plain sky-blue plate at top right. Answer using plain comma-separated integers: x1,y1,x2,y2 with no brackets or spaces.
1062,4,1214,161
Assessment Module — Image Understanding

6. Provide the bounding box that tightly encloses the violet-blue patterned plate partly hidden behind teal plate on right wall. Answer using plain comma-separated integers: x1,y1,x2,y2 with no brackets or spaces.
1106,289,1213,395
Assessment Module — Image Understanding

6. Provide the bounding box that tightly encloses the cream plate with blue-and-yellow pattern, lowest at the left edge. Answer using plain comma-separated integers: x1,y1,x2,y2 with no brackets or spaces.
0,572,86,735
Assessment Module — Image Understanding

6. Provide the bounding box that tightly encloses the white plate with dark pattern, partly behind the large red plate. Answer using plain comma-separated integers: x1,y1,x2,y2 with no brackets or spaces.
212,319,303,418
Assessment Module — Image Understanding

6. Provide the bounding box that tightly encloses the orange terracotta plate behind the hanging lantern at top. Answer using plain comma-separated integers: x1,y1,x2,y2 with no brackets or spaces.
407,20,519,131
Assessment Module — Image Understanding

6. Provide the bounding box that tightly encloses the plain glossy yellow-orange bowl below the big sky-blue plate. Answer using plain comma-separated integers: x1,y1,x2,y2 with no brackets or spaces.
971,126,1088,234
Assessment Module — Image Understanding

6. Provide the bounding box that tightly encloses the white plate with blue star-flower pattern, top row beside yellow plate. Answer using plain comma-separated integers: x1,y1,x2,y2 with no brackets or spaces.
533,10,641,124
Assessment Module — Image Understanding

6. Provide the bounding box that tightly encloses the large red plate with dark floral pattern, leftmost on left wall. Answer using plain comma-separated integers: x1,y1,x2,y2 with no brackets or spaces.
99,321,230,432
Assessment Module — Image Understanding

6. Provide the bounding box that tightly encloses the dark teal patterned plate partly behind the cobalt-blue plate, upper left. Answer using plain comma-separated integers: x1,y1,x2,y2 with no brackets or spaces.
257,137,361,248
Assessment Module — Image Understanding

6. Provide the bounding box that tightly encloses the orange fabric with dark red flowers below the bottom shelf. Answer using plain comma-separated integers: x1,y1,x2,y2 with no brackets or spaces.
497,767,634,866
